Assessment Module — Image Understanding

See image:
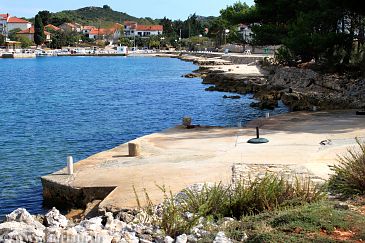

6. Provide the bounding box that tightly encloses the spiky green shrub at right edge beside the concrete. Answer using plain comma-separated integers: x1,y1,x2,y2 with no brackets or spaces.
328,139,365,197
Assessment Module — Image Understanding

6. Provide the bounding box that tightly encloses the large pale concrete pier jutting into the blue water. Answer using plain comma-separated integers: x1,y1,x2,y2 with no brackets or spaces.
42,111,365,211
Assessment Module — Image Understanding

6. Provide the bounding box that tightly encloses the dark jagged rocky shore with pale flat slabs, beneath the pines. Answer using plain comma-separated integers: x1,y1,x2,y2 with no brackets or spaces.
179,55,365,111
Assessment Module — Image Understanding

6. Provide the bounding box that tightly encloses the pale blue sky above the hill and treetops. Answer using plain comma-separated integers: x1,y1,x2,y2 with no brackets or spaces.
0,0,254,19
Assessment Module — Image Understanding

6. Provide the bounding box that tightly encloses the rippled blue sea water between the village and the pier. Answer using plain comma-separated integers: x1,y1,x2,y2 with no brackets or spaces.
0,57,286,217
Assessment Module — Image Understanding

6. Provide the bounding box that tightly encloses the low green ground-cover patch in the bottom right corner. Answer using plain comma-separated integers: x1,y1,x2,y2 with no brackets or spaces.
225,201,365,242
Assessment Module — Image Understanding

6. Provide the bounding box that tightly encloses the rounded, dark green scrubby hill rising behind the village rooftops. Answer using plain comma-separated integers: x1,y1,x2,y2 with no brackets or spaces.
31,5,156,27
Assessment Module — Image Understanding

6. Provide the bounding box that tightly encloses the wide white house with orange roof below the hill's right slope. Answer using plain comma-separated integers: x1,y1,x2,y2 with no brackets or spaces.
124,21,163,37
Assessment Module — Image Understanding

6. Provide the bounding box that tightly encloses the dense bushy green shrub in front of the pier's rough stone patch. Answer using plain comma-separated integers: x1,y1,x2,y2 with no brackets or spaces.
178,174,325,219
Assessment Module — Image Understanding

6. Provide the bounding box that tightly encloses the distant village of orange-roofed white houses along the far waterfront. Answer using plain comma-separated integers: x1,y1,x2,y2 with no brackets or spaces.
0,9,258,58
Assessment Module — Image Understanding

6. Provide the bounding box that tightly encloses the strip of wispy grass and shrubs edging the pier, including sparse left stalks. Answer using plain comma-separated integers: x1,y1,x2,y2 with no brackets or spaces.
135,174,325,237
